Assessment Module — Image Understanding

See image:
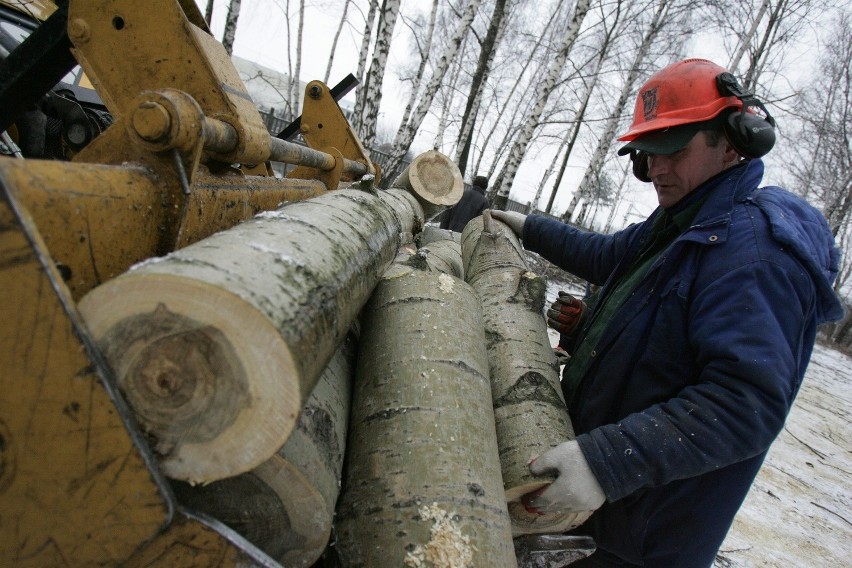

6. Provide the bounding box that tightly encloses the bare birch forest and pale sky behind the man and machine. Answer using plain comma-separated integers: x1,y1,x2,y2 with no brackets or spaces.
196,0,852,348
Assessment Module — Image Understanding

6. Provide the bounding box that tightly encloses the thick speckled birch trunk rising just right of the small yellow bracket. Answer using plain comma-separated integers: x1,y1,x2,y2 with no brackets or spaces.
355,0,400,148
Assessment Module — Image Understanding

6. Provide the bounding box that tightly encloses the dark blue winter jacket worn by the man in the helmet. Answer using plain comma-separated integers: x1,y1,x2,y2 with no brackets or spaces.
523,160,843,567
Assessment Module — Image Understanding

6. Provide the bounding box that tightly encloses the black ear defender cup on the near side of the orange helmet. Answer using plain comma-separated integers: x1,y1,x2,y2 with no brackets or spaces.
716,73,775,160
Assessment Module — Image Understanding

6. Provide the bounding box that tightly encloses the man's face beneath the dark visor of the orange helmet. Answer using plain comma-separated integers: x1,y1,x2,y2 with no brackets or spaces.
648,131,736,208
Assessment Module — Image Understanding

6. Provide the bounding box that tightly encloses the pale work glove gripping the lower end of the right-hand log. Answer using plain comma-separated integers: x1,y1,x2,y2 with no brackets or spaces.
522,440,606,513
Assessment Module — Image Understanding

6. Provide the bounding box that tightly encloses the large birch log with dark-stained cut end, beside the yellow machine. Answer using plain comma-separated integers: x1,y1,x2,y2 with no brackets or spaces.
79,189,423,483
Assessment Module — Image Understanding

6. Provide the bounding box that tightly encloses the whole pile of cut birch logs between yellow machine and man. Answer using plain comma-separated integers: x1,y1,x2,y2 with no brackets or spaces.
79,152,578,567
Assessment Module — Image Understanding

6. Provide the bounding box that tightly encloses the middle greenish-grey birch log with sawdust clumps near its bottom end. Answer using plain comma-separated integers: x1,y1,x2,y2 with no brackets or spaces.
336,254,517,568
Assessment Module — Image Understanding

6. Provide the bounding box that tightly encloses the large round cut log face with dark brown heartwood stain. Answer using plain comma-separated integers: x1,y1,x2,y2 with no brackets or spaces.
80,273,303,483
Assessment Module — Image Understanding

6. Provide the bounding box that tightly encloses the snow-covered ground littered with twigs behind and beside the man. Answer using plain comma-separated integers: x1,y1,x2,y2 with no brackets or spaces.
534,267,852,568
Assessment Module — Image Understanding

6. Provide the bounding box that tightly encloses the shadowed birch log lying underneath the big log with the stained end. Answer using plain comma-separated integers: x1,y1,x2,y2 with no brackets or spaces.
172,334,356,568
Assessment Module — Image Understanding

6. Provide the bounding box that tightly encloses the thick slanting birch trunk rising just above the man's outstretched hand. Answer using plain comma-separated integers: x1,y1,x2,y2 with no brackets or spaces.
494,0,591,209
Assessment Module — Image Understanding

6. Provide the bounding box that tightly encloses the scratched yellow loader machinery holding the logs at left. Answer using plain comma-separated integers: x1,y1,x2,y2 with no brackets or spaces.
0,0,378,566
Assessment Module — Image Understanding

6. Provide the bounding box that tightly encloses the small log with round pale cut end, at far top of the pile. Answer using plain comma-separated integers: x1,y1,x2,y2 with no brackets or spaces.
391,150,464,219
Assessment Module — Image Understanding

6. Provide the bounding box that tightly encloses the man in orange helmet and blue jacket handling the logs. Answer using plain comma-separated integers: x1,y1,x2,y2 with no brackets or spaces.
494,59,842,567
